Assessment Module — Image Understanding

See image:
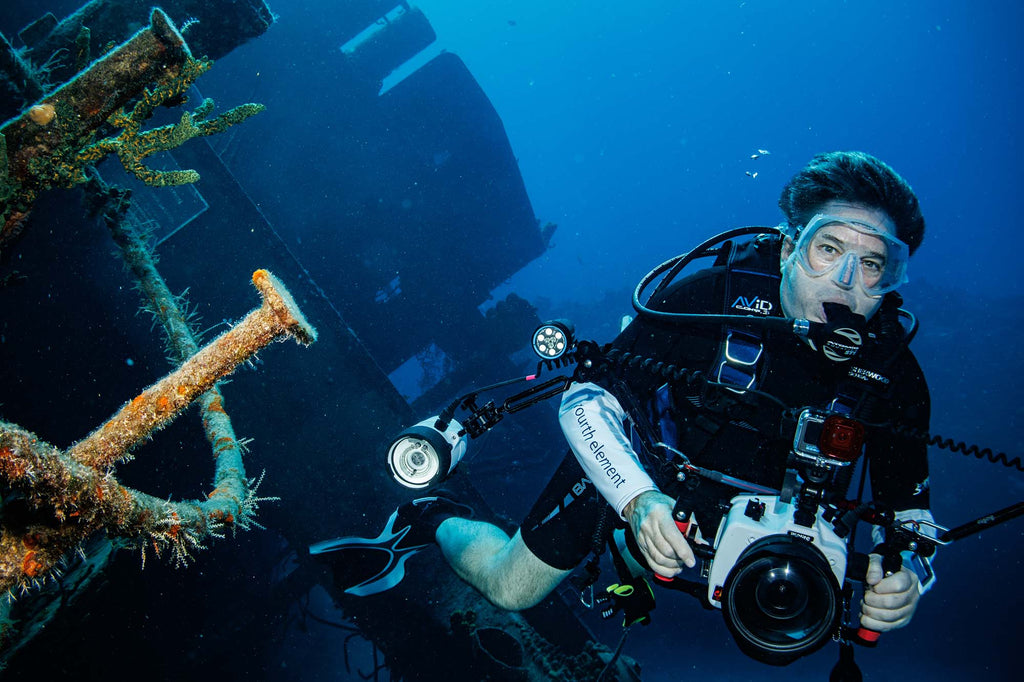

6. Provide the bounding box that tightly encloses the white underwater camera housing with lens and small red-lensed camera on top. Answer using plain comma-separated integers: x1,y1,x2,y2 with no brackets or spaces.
684,409,864,665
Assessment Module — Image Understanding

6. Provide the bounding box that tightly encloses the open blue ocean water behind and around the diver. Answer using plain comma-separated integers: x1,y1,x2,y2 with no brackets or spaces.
4,0,1024,681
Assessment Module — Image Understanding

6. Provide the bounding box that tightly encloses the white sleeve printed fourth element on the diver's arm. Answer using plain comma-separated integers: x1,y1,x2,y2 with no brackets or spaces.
558,383,657,516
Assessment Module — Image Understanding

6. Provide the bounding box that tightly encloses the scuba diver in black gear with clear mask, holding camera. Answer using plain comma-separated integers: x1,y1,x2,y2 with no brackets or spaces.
310,152,935,664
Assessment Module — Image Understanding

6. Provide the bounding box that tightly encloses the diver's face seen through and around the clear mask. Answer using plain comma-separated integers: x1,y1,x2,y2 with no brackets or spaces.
779,201,895,323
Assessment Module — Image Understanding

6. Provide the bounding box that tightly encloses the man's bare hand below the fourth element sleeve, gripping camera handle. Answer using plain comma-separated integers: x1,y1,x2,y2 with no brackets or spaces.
623,491,696,578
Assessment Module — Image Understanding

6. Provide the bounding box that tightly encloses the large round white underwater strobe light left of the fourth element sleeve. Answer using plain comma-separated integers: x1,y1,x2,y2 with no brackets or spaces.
387,417,467,489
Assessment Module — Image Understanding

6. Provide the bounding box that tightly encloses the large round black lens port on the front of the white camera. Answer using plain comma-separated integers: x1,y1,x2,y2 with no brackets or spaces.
722,535,841,665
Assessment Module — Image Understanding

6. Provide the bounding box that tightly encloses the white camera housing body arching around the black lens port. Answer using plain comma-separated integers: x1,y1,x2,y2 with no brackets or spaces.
708,495,847,608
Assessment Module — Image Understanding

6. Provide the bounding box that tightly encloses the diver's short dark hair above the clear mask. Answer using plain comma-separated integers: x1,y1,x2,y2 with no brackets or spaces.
778,152,925,255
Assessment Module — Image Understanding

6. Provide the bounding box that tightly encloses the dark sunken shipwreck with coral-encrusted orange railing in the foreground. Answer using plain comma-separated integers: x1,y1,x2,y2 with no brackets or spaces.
0,0,635,680
